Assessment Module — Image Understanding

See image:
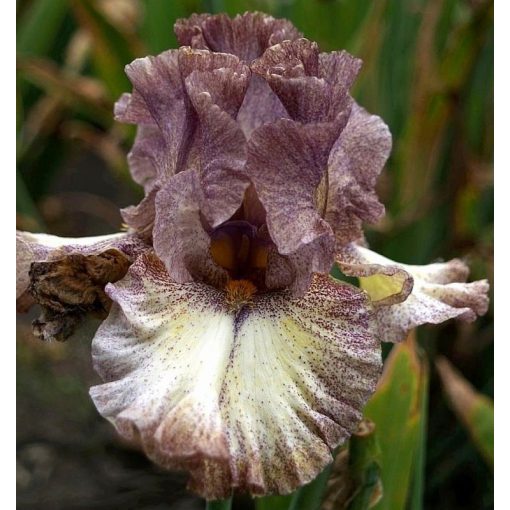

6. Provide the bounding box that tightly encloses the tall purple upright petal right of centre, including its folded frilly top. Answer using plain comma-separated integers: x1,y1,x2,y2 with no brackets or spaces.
246,39,360,292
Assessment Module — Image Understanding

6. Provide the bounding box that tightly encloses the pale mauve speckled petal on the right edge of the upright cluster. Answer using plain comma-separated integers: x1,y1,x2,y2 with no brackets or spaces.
324,103,391,246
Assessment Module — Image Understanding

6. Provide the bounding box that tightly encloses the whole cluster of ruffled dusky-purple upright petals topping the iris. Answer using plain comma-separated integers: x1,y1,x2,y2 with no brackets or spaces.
110,13,391,295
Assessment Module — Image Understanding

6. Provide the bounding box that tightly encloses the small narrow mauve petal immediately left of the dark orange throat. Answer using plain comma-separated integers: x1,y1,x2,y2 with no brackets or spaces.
154,170,227,288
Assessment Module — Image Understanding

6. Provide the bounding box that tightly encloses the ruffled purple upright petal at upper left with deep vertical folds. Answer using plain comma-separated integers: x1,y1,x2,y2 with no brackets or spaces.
116,48,250,237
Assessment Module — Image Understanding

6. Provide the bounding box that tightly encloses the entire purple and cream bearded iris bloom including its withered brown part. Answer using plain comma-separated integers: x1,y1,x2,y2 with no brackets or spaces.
13,13,488,499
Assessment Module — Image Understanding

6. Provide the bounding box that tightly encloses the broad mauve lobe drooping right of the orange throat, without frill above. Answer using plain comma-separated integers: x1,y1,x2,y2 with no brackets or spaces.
247,120,340,290
